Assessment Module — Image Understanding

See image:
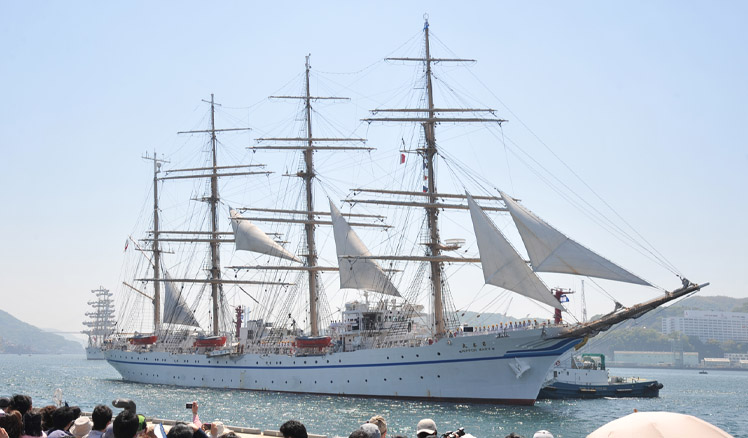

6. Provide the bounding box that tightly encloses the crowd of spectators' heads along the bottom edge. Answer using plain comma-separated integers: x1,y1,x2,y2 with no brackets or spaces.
0,394,553,438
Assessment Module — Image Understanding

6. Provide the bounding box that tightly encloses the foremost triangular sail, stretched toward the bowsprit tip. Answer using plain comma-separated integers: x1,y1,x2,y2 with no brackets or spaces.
501,192,650,286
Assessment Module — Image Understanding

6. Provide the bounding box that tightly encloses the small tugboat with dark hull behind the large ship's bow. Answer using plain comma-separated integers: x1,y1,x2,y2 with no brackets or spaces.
538,354,663,399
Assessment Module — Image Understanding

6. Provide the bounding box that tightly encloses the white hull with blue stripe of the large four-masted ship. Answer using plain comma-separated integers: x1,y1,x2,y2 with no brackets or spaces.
105,328,580,405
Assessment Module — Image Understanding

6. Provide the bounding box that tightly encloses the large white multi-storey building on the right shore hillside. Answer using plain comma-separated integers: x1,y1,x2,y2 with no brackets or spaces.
662,310,748,342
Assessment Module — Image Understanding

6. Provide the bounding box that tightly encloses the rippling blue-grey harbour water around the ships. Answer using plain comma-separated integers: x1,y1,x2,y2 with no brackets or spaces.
0,355,748,438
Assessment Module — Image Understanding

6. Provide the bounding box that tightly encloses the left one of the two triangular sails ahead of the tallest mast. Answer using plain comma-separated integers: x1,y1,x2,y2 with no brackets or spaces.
467,194,564,310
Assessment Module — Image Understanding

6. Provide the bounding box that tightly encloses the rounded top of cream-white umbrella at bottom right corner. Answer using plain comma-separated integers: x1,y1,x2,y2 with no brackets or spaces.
587,412,732,438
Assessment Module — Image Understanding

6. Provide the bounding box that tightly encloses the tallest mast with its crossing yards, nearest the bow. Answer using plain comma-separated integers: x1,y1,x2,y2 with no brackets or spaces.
364,15,505,337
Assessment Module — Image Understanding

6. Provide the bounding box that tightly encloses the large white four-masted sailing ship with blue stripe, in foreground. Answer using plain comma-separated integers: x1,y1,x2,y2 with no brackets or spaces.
105,21,705,405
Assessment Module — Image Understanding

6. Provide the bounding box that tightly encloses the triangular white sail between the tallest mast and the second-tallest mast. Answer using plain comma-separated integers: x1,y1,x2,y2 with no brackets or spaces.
330,201,400,297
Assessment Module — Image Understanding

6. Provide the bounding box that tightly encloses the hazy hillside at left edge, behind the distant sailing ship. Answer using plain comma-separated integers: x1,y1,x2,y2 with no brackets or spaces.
0,310,83,354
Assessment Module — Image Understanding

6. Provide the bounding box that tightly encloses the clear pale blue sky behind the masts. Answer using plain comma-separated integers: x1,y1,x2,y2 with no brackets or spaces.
0,1,748,332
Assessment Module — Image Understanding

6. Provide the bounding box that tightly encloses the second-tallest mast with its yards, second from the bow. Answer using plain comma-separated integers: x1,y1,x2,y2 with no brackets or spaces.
252,55,372,336
